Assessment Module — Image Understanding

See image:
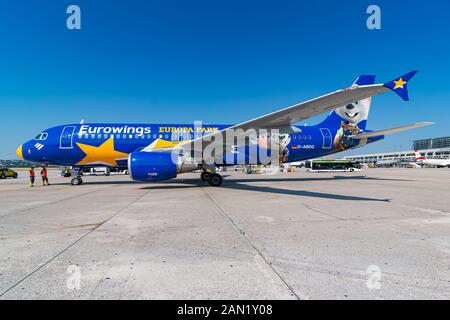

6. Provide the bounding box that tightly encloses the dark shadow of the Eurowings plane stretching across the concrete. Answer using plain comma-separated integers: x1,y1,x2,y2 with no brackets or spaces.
138,176,398,202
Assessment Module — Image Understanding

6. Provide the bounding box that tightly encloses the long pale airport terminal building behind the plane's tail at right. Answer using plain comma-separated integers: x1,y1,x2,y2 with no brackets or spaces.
345,136,450,164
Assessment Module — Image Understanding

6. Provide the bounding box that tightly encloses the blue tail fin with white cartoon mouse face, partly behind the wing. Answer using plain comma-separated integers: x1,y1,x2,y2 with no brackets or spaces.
321,75,375,130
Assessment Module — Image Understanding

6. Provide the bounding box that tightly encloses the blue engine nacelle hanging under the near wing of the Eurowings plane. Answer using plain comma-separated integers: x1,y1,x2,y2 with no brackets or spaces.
128,151,198,182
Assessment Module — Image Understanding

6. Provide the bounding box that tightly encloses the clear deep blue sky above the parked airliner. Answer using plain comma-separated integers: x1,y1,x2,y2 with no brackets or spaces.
0,0,450,159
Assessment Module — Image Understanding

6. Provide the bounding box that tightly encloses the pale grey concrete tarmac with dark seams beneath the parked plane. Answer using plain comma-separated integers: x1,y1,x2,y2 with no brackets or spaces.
0,168,450,299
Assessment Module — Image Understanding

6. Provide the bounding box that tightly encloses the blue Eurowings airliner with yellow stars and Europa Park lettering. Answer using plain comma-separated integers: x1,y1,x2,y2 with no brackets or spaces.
17,71,431,186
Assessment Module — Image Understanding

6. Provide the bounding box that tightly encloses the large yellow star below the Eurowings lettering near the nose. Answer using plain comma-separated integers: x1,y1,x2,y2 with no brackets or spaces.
77,137,128,167
